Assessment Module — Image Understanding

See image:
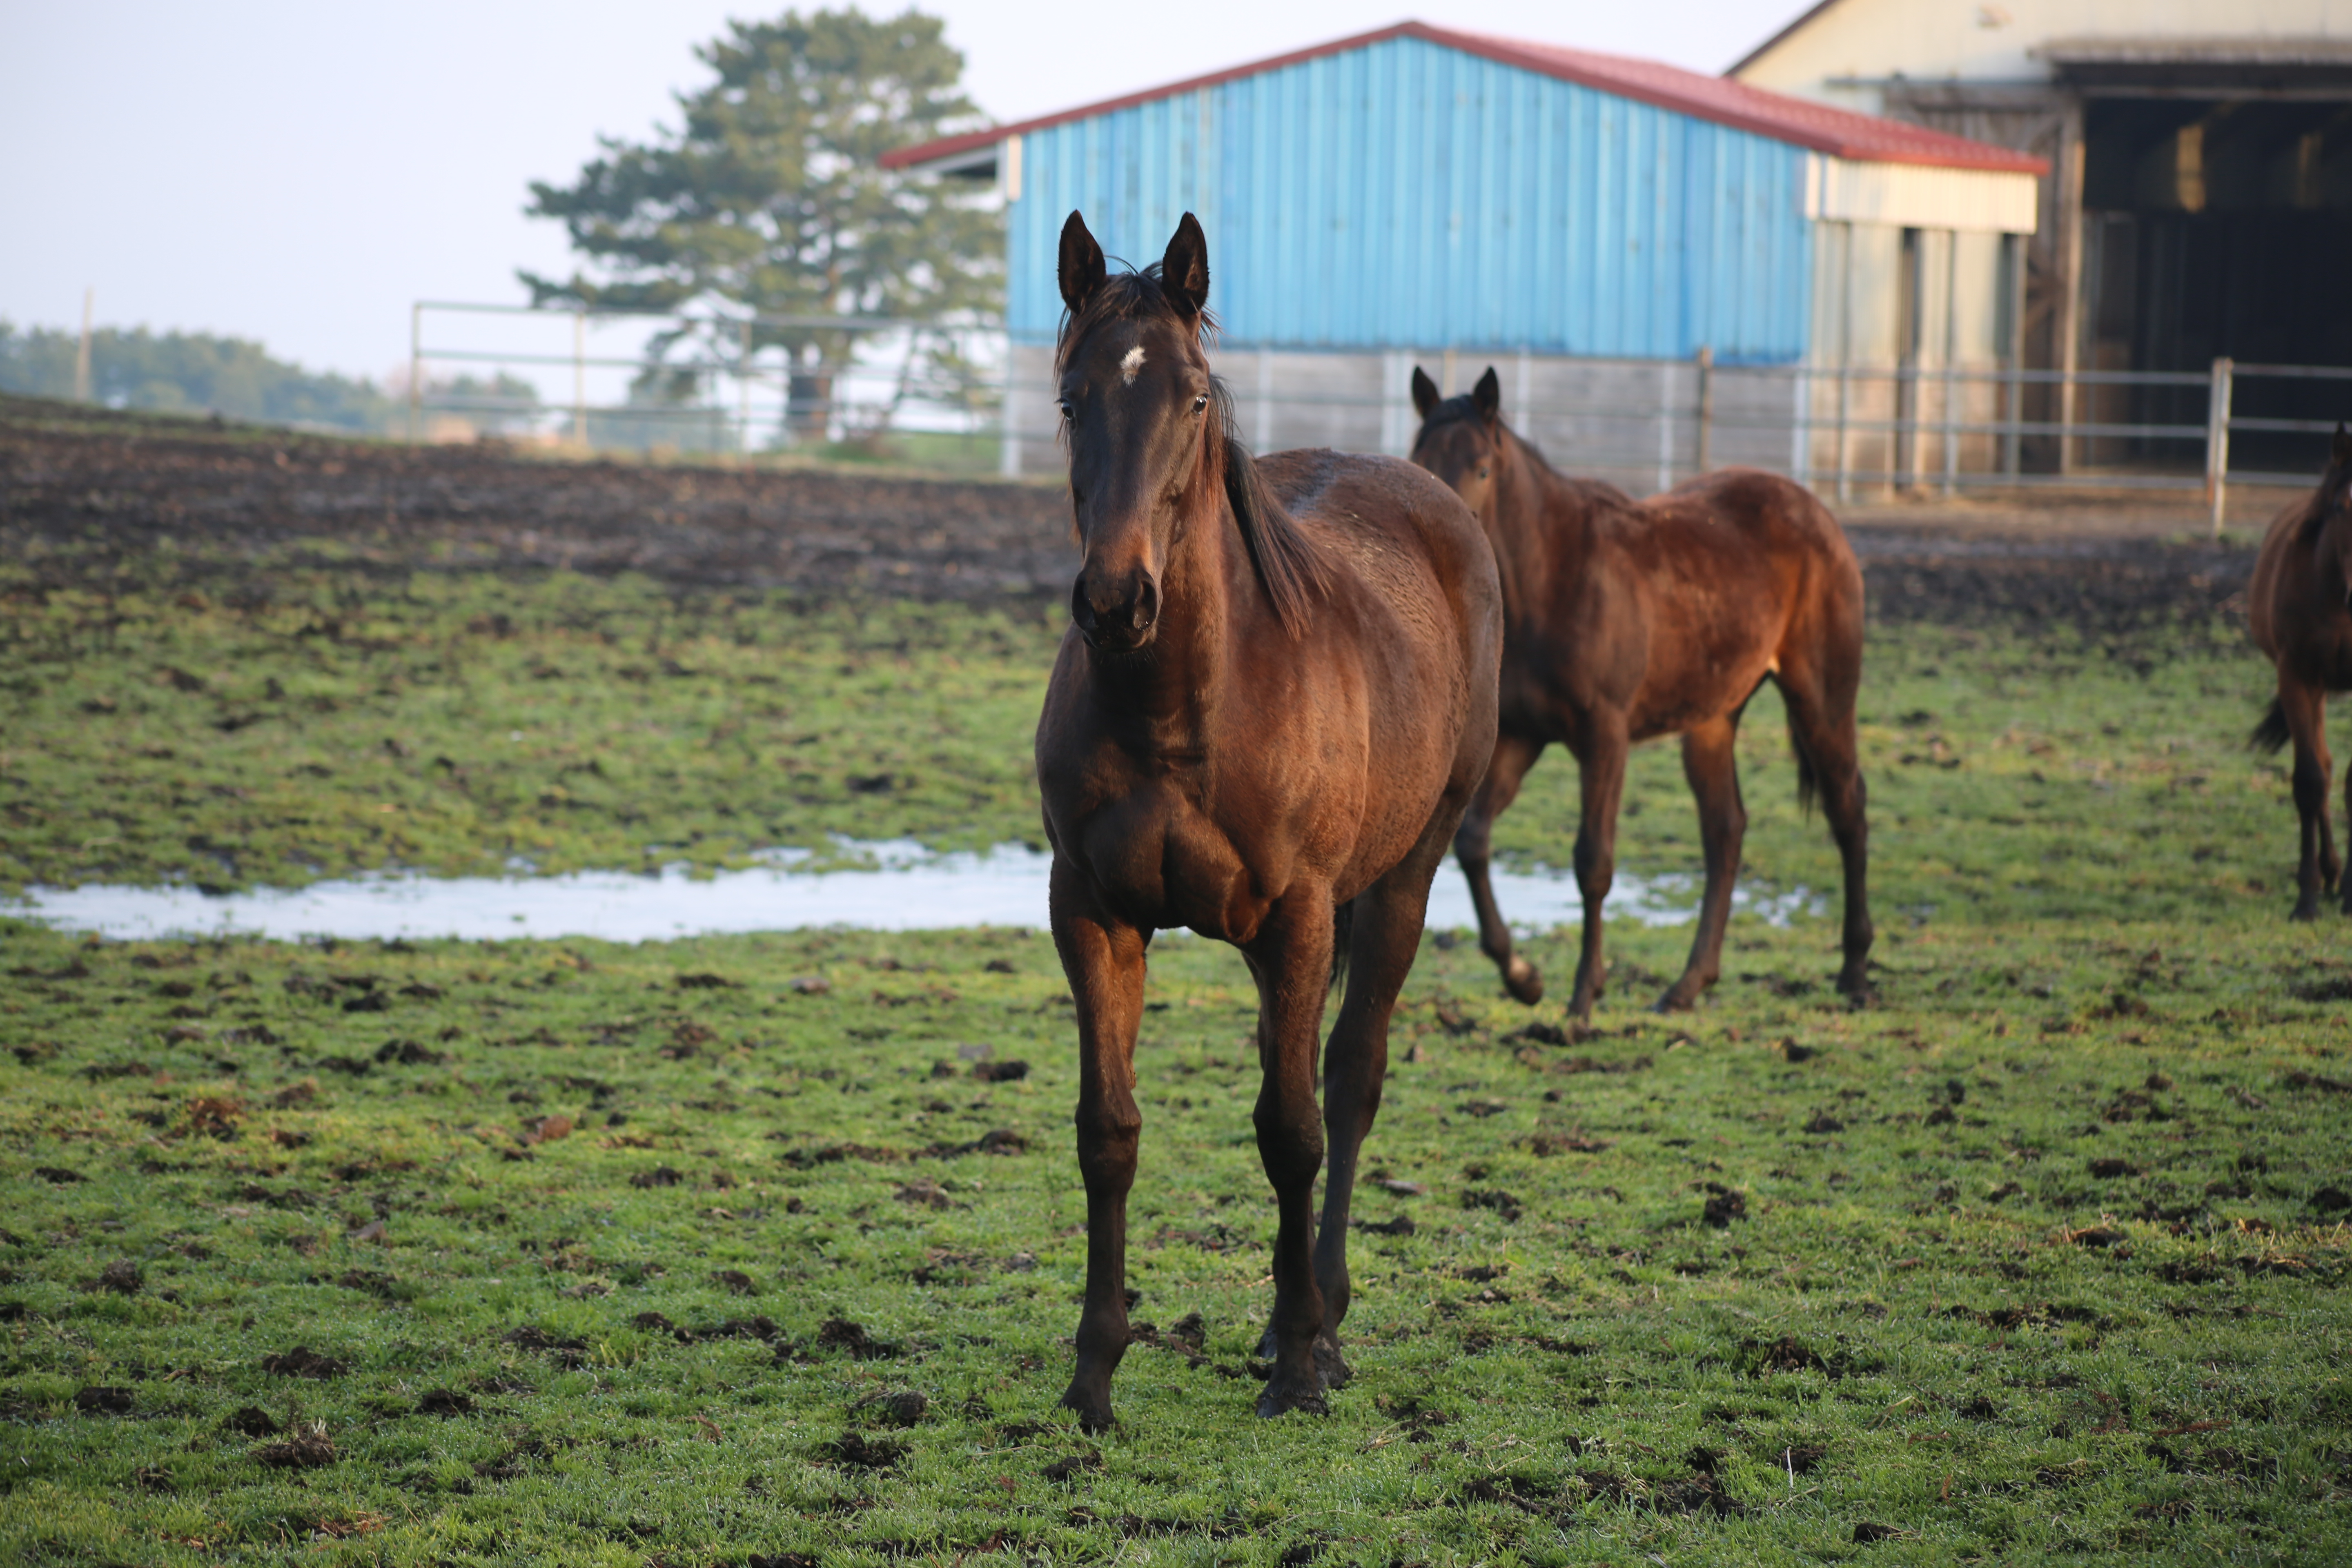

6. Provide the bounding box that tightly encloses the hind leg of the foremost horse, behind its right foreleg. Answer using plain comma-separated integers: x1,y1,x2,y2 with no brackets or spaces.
1315,811,1454,1387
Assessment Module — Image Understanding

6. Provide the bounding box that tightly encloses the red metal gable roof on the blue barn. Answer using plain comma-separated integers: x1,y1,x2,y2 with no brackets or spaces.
882,21,2049,174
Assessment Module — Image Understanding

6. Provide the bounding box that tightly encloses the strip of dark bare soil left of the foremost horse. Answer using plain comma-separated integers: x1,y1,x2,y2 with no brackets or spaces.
0,397,1070,599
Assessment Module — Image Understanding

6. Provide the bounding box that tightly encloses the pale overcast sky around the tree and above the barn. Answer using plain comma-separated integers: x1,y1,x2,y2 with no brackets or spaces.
0,0,1802,376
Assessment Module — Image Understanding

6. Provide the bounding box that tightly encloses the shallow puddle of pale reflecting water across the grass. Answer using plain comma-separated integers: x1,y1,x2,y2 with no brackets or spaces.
0,839,1820,943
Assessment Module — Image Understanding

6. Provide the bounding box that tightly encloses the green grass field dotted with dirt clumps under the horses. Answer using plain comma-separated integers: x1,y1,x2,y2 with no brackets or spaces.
0,557,2352,1568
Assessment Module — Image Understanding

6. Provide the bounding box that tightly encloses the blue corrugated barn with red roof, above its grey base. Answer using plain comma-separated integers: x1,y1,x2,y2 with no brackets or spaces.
884,24,2039,482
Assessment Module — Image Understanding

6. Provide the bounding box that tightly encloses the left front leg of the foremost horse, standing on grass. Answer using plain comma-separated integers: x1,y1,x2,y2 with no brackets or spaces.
1051,856,1150,1432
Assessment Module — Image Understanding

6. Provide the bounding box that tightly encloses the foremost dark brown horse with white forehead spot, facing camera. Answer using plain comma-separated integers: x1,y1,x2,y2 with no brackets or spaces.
1037,212,1503,1432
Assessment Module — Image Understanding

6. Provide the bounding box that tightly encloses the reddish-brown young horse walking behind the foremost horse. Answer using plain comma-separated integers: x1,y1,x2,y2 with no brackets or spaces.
1414,369,1872,1018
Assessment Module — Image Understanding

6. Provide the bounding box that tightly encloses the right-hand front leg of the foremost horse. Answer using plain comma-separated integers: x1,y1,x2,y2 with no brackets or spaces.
1249,889,1334,1415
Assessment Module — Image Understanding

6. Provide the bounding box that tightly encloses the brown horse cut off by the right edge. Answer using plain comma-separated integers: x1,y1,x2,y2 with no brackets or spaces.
2246,425,2352,919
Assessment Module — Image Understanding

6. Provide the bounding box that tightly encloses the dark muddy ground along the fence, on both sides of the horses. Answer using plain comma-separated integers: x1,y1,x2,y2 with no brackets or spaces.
0,397,2279,637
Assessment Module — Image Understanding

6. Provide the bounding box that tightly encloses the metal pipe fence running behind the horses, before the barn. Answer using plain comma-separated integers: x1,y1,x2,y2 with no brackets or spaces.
407,301,2352,534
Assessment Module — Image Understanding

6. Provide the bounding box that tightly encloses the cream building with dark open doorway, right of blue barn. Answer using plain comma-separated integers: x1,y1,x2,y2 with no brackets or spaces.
1726,0,2352,470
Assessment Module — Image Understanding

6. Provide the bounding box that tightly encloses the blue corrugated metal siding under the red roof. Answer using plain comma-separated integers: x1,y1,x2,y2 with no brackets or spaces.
1007,38,1811,362
